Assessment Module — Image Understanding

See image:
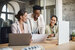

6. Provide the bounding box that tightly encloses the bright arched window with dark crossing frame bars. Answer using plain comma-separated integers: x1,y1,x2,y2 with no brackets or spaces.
1,4,15,21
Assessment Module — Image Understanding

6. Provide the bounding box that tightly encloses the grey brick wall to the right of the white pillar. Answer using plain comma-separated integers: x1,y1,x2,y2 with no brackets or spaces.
63,0,75,34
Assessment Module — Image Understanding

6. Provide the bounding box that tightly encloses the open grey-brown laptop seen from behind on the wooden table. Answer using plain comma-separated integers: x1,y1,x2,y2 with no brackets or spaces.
9,33,32,46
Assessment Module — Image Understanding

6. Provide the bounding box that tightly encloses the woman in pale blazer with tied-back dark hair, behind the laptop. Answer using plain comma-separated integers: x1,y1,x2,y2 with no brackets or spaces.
11,9,29,33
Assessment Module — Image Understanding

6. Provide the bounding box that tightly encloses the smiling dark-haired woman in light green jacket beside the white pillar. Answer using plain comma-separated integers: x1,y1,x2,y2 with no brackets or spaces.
45,15,58,38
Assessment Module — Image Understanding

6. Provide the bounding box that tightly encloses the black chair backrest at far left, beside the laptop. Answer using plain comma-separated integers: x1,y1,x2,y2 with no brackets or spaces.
1,27,11,43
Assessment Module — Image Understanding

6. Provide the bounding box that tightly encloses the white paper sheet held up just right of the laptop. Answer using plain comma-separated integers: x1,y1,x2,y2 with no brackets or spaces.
32,34,48,42
